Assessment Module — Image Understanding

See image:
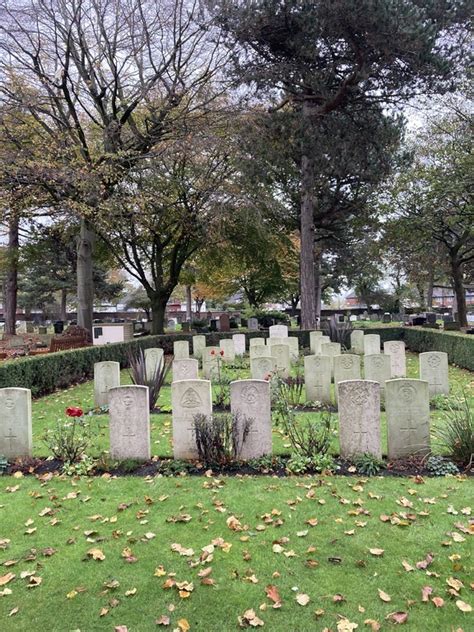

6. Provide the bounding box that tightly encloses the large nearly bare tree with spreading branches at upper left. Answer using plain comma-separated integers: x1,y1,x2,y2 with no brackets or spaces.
0,0,223,330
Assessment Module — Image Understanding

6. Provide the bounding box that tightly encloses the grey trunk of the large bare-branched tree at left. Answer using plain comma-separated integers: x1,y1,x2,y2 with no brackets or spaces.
77,218,95,340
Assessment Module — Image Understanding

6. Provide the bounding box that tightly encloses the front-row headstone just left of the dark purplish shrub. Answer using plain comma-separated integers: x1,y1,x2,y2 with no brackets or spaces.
171,380,212,459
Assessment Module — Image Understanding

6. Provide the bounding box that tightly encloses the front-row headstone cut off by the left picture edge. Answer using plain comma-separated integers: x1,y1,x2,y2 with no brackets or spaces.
0,387,32,459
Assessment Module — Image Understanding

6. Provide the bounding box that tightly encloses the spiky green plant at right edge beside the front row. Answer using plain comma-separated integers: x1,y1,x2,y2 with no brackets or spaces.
434,392,474,468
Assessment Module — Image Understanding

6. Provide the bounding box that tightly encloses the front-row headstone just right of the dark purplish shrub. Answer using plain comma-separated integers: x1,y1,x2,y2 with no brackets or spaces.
230,380,272,459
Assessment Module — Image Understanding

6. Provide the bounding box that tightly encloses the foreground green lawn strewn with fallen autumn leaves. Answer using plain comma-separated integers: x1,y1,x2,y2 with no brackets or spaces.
0,477,474,632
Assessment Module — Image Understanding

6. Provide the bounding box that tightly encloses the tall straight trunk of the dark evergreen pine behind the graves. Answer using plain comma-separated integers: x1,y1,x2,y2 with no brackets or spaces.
300,102,316,329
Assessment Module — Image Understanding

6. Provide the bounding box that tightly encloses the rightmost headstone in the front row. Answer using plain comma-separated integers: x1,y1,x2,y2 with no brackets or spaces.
385,378,430,459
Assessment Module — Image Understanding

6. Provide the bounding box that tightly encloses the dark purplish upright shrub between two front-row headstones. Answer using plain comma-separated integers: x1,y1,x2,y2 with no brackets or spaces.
194,414,253,466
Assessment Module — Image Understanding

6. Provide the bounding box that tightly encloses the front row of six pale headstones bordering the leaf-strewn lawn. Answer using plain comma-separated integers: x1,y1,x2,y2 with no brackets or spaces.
0,378,430,460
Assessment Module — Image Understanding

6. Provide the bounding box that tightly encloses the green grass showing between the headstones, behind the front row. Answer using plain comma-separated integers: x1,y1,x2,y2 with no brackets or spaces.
33,353,474,457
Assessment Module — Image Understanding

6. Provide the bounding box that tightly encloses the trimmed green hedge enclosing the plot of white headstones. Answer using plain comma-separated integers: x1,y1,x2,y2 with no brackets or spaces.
0,327,474,397
